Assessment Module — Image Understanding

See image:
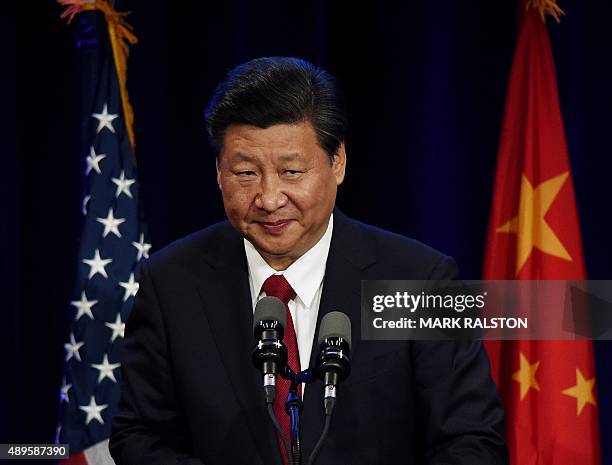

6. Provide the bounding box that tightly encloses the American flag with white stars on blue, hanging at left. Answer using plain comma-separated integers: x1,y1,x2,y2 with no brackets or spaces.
57,4,151,465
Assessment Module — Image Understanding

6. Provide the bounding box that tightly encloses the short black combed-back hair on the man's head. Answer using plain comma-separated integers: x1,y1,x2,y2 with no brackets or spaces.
205,57,347,160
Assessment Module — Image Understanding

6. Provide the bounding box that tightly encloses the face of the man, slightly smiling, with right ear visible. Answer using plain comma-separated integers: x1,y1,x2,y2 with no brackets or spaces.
217,122,346,270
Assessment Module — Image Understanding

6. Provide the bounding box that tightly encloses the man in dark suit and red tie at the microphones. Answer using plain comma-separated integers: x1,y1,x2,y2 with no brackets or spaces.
110,58,508,465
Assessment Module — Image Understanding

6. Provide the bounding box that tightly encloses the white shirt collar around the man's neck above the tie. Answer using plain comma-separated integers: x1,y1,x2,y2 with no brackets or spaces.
243,213,334,308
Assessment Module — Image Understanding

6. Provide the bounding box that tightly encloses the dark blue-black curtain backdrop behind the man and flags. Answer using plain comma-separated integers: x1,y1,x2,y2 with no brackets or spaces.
0,0,612,458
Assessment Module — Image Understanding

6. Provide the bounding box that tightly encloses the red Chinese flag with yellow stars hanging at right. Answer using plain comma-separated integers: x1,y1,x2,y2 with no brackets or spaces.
484,0,600,465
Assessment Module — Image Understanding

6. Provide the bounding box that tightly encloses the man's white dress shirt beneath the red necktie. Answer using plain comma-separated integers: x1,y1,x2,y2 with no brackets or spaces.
244,214,334,393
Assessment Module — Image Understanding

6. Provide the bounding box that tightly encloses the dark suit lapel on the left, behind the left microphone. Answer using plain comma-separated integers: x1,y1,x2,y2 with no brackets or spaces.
199,225,282,465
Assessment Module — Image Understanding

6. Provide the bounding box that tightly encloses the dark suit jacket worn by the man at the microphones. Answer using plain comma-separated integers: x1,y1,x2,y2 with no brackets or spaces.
110,210,508,465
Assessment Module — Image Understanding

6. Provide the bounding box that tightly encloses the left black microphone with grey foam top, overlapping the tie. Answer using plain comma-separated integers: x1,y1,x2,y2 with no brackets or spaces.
253,297,287,403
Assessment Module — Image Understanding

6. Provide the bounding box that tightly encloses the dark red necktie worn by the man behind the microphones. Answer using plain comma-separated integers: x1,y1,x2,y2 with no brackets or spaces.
262,274,302,465
